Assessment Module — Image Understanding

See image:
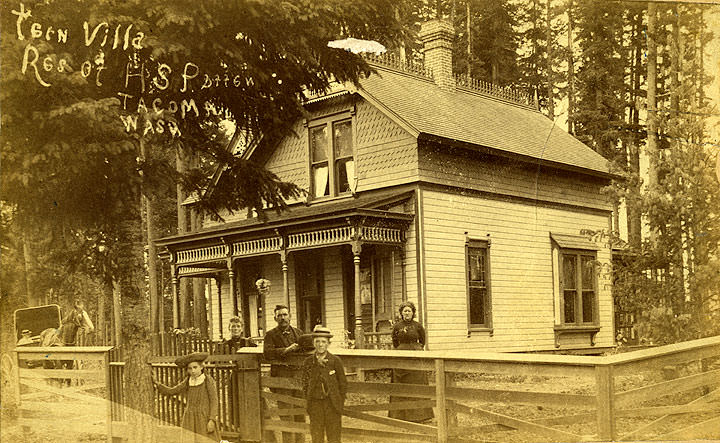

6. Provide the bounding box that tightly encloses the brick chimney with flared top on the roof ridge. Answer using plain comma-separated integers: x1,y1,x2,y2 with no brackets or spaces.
418,19,455,92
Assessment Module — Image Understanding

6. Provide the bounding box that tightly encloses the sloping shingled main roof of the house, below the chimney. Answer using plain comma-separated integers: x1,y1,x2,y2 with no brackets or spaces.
358,64,609,174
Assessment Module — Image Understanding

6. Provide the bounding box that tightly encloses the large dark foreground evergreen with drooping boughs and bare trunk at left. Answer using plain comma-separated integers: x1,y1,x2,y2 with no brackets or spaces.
0,0,399,441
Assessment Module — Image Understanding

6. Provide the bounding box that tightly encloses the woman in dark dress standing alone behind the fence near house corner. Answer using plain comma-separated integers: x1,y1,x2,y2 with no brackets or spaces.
388,301,433,422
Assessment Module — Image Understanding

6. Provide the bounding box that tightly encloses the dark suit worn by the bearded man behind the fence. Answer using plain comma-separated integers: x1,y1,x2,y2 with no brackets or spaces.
263,326,305,443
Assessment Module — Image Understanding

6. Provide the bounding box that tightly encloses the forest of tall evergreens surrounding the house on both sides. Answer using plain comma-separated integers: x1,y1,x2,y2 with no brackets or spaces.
0,0,720,438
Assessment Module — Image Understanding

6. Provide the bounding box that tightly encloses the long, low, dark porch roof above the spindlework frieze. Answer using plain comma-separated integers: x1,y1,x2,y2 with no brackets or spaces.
155,189,414,249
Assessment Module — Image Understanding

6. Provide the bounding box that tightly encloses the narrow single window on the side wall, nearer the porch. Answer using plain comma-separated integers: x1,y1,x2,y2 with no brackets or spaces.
465,240,492,330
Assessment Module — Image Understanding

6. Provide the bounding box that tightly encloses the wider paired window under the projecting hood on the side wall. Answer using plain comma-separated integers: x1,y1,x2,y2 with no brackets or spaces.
560,249,598,326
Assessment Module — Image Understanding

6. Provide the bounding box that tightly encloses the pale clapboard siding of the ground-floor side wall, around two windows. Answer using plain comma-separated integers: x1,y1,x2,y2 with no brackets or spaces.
421,190,613,351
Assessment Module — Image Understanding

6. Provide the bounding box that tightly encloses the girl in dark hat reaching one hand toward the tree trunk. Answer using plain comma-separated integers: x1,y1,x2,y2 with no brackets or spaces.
152,352,220,443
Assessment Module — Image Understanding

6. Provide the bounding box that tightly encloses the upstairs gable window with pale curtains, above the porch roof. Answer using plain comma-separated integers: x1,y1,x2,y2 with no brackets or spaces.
309,118,355,198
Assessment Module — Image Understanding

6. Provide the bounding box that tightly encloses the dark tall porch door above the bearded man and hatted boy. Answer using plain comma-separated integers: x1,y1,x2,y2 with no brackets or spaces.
295,251,325,333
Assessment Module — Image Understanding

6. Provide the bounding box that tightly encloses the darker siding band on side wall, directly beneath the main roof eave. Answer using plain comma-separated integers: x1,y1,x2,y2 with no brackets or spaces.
419,146,611,210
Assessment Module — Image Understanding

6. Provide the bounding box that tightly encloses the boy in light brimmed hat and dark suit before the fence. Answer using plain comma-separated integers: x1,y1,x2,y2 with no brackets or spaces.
302,325,347,443
